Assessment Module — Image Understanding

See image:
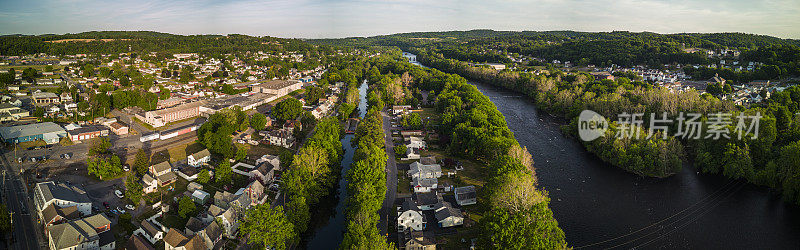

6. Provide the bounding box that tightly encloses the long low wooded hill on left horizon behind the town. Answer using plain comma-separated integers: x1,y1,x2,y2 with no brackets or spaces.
0,31,314,56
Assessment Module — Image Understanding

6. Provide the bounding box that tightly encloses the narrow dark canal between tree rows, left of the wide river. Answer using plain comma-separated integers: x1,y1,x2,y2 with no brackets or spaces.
302,81,367,249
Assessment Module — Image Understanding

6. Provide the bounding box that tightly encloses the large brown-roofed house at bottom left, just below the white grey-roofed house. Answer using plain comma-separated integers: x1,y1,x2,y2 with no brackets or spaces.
46,214,115,249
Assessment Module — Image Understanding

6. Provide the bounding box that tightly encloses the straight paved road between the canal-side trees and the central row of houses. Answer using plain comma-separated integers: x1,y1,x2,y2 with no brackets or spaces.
379,111,397,235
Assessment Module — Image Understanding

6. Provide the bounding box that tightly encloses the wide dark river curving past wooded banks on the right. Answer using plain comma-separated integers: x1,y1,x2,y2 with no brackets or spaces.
404,52,800,249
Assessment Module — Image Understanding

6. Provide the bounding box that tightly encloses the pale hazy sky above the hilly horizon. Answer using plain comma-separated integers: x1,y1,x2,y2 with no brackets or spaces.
0,0,800,39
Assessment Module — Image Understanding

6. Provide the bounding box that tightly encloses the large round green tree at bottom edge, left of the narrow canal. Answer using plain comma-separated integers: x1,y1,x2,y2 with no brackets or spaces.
242,204,297,250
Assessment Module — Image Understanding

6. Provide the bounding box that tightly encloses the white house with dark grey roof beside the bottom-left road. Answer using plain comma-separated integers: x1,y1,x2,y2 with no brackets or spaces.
33,181,92,221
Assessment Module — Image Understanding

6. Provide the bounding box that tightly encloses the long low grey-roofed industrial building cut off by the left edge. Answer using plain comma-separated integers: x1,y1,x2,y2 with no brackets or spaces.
0,122,67,144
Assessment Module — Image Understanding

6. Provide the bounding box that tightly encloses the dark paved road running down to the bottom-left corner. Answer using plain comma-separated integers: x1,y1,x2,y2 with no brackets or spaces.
0,147,41,249
